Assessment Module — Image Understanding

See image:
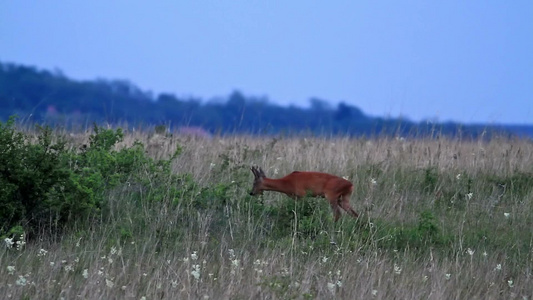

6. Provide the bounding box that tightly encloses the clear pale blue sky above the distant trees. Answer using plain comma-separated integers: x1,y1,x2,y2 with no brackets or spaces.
0,0,533,124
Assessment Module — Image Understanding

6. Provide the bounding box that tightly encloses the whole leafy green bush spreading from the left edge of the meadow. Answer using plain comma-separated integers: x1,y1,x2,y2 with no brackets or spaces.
0,118,179,236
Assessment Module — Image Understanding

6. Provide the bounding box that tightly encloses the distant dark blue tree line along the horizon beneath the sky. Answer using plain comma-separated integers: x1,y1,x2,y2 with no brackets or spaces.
0,62,533,137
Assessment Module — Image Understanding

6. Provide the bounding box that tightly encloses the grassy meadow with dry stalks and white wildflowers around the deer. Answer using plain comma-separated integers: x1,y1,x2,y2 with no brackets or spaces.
0,123,533,299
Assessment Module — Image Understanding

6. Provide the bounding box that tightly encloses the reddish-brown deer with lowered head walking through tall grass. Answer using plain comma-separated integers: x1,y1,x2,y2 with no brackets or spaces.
250,167,358,222
